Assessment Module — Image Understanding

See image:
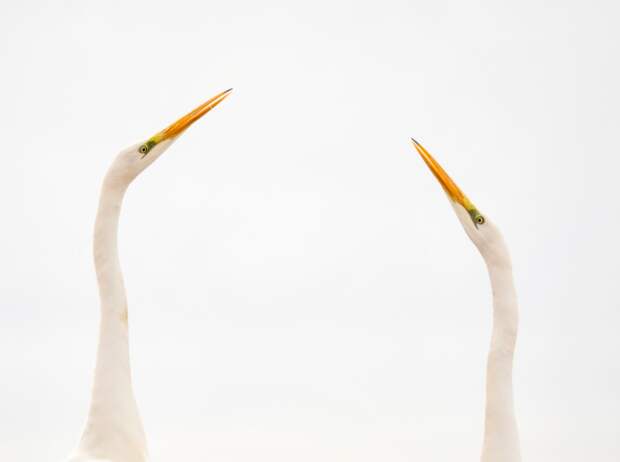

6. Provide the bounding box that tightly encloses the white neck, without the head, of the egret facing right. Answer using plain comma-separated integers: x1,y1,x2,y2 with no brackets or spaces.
72,174,147,462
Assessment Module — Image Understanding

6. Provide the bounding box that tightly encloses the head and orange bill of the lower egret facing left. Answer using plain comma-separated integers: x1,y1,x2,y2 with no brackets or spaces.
411,138,507,259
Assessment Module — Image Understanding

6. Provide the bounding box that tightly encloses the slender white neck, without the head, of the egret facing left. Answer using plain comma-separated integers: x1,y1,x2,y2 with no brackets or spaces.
481,249,521,462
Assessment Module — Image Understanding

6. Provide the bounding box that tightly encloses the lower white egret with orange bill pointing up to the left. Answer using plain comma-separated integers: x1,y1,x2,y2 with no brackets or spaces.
412,138,521,462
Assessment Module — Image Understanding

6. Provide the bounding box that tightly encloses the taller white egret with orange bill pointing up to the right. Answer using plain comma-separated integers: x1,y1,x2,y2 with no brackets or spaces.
69,89,232,462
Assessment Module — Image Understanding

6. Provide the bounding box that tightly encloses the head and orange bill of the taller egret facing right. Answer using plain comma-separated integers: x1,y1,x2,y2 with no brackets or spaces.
107,88,232,185
